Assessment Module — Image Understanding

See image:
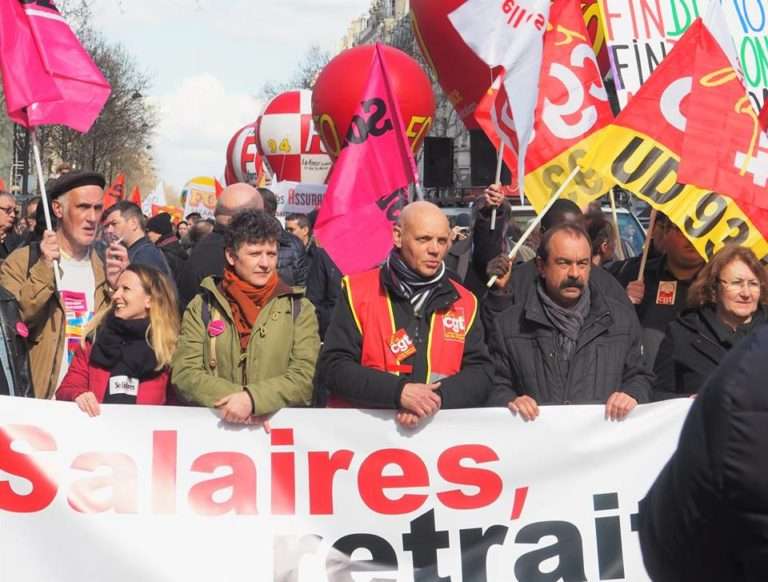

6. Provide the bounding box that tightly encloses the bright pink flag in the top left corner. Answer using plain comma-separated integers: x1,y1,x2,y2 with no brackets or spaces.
0,0,110,133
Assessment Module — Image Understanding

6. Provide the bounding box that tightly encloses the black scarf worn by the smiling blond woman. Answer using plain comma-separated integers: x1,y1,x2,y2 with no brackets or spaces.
90,313,159,404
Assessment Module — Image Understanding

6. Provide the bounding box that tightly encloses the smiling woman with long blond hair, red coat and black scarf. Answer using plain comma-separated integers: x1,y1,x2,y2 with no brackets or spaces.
56,265,179,416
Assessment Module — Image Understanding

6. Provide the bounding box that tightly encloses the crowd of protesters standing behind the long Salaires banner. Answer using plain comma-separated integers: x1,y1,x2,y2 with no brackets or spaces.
0,172,768,434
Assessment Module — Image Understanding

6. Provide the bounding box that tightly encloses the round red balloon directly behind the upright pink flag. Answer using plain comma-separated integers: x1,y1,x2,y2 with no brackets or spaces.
312,45,435,159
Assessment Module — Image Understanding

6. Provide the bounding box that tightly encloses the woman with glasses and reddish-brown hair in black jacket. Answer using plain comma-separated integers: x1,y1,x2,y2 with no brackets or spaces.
654,246,768,400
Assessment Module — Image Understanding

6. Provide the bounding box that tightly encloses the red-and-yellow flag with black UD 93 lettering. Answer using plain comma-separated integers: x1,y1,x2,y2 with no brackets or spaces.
582,19,768,259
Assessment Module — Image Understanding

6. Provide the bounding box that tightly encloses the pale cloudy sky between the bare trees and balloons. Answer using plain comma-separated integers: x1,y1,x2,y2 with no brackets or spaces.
91,0,370,188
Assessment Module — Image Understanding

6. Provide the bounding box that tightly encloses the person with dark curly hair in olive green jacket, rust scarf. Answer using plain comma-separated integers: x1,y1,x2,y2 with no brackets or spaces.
172,210,320,423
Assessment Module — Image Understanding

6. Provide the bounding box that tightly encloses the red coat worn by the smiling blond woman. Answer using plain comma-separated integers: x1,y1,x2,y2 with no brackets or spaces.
56,343,170,404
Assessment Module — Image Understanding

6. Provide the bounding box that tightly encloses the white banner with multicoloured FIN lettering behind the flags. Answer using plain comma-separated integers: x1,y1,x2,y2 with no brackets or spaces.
599,0,768,111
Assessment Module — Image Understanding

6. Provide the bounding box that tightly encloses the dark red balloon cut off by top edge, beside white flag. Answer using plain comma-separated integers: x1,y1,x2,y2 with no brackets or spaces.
411,0,492,129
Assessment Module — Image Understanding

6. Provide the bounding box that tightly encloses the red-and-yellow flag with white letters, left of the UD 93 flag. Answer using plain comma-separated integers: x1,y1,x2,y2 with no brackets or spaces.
475,0,613,212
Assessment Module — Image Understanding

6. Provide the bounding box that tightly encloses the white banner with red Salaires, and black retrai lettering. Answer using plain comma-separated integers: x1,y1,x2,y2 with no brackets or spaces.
0,397,690,582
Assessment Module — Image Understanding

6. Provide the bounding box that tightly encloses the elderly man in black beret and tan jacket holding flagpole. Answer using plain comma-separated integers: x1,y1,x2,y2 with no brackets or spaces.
0,171,128,398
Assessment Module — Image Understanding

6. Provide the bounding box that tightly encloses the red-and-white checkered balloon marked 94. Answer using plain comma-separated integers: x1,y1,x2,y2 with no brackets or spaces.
256,90,331,184
